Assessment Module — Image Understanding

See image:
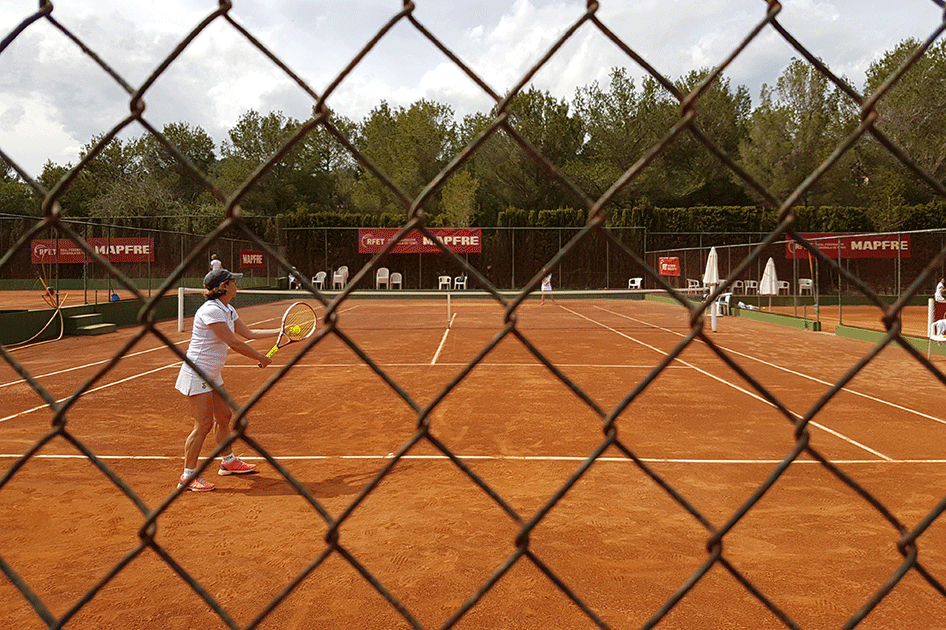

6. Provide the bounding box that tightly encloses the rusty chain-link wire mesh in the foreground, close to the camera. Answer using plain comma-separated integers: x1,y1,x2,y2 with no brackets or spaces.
0,0,946,628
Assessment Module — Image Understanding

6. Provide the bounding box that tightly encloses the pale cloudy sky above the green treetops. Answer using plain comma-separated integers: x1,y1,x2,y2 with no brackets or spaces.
0,0,943,175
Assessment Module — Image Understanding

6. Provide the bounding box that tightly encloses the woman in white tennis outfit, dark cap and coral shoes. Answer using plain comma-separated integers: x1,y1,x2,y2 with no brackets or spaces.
175,269,279,492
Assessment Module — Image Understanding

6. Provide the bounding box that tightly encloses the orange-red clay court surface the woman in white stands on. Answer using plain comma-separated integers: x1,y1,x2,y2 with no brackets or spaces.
0,294,946,629
